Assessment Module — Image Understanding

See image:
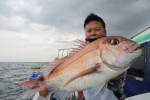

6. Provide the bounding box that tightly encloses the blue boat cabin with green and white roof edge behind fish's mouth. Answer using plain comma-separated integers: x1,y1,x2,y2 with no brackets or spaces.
124,27,150,100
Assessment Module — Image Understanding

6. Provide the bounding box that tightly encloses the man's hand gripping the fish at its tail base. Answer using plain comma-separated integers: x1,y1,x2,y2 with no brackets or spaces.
36,75,49,98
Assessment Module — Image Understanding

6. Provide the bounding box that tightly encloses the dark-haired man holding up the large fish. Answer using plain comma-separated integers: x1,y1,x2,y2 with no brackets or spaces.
37,13,125,100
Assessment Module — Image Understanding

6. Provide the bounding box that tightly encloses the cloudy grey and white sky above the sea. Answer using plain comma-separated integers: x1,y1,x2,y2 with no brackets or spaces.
0,0,150,62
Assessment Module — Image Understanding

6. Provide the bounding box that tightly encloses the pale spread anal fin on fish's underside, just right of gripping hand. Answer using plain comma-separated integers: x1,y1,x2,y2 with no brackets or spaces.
48,87,74,100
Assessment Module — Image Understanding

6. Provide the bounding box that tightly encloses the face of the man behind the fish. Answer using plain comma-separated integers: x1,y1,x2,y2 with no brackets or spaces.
84,21,106,39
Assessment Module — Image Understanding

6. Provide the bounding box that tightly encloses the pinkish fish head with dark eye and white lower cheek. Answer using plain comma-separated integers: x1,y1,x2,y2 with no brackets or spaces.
99,36,142,70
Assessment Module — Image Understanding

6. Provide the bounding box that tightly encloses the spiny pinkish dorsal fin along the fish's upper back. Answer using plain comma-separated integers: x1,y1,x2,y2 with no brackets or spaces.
44,40,89,78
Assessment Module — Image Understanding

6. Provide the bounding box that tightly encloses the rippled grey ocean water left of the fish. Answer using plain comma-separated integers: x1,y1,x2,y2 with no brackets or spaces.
0,62,48,100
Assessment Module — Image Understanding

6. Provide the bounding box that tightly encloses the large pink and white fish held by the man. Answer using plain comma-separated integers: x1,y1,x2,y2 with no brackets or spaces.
22,36,142,100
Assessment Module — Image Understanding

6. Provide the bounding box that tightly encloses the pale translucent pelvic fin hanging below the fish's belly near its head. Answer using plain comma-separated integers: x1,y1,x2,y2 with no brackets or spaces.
92,82,108,97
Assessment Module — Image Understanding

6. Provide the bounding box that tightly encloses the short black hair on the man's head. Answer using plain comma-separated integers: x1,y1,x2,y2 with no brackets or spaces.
84,13,106,29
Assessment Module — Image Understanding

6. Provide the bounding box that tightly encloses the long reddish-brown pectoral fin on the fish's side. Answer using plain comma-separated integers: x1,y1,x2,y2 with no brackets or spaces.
64,63,101,86
